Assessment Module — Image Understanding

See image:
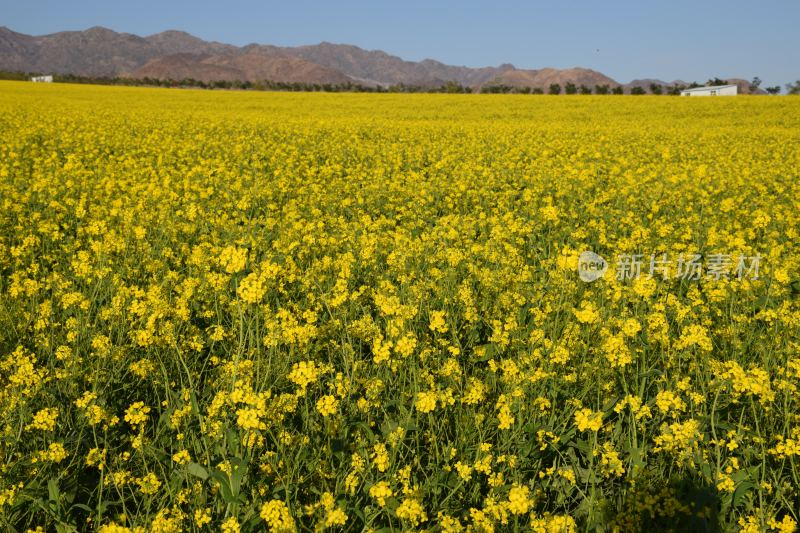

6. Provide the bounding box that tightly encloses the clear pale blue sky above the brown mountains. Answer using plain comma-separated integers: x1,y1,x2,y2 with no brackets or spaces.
0,0,800,87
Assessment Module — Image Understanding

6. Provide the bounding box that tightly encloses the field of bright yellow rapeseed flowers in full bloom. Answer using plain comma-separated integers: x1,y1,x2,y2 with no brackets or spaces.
0,82,800,533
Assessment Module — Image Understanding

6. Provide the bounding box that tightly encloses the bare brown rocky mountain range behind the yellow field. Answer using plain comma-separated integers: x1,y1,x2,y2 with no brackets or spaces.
0,26,764,92
